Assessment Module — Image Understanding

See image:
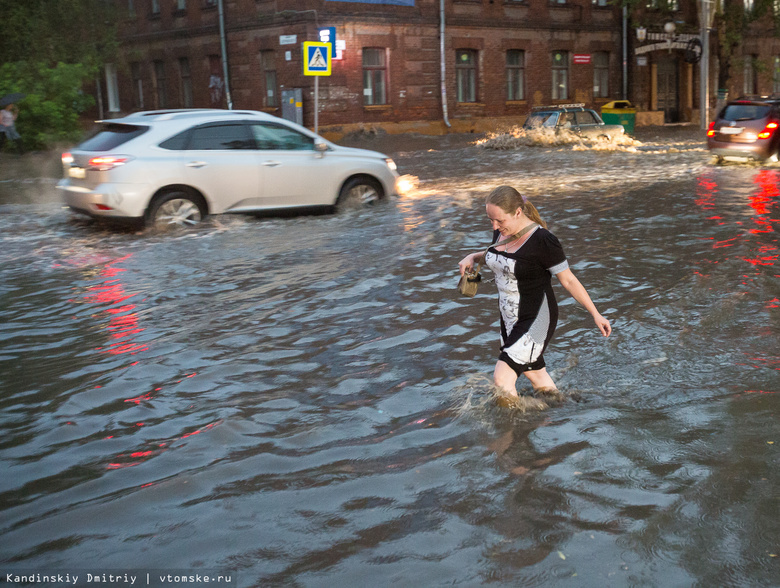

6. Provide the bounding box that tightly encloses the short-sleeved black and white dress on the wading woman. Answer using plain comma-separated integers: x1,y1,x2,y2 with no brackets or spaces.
485,227,569,374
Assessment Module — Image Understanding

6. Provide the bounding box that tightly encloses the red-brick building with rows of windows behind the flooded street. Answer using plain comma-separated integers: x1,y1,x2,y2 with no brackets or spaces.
105,0,780,133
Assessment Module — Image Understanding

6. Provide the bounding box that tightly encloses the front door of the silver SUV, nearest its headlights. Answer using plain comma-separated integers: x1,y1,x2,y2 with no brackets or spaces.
250,121,341,208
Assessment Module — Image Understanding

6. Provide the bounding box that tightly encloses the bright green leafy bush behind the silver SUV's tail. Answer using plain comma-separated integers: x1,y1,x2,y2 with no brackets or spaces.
0,62,94,149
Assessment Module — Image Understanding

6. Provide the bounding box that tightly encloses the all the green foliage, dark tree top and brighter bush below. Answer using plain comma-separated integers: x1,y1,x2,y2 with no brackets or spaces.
0,0,117,149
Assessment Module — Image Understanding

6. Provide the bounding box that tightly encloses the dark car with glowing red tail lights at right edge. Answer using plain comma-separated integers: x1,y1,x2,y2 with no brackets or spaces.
707,96,780,163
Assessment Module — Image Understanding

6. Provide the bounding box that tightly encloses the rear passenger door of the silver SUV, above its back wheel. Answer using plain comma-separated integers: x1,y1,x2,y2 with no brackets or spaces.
181,122,263,213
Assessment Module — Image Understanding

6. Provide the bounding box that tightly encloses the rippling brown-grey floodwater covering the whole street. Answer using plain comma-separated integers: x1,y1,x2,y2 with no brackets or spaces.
0,130,780,587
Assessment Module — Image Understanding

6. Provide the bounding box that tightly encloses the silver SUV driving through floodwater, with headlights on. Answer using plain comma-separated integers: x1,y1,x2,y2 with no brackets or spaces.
57,110,399,228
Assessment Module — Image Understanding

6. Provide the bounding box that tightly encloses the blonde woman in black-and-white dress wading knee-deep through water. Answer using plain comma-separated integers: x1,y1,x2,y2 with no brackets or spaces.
458,186,612,404
